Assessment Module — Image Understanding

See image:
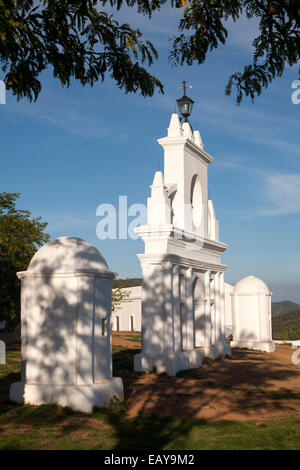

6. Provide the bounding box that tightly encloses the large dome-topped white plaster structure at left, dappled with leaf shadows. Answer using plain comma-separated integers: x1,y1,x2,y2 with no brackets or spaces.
10,237,123,411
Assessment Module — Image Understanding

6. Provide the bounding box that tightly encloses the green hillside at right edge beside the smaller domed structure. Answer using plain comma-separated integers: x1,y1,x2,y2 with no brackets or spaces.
272,309,300,340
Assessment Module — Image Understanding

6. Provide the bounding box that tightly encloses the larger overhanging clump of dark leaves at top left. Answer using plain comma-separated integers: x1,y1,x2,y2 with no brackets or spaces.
0,0,162,100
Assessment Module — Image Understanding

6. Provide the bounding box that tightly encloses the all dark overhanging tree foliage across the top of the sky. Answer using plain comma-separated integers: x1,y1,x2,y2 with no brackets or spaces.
0,0,300,103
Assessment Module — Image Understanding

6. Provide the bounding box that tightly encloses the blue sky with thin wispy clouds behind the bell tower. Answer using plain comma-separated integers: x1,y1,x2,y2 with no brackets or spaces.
0,4,300,302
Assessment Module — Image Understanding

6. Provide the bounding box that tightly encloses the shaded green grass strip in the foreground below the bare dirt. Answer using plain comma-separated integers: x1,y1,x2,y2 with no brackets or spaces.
0,338,300,450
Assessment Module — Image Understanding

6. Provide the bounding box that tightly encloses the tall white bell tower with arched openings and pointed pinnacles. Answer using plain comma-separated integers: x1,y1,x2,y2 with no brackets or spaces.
134,96,230,375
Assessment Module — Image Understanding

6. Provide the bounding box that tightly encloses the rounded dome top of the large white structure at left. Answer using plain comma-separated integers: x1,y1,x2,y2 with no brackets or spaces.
27,237,110,273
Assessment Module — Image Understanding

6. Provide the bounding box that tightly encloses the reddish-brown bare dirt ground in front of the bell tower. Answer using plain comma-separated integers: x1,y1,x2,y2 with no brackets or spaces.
113,332,300,423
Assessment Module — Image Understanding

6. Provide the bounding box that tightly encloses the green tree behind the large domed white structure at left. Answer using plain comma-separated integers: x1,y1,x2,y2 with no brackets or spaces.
0,193,49,329
